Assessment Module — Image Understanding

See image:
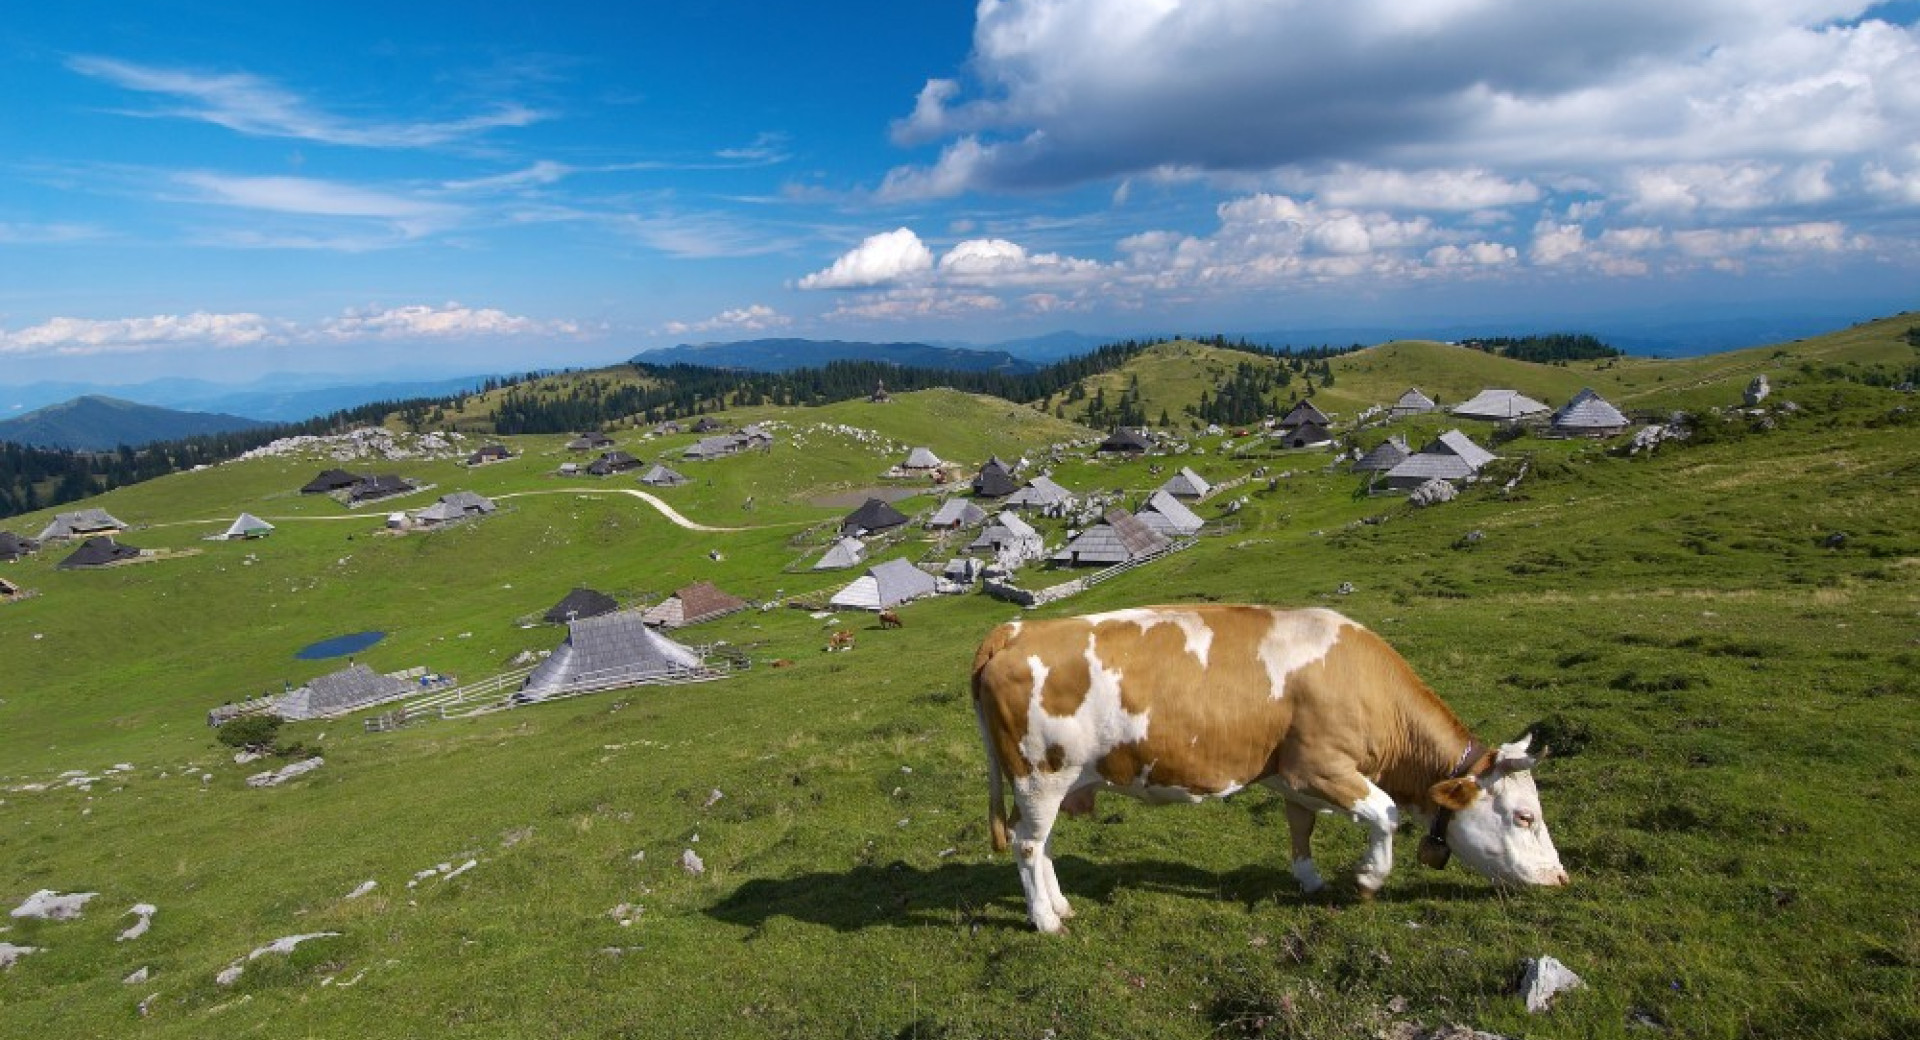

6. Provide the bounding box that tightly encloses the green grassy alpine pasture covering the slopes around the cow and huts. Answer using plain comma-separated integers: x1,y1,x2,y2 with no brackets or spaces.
0,317,1920,1038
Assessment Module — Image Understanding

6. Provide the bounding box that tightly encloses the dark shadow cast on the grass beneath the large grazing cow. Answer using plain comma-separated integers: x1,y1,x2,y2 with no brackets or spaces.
707,856,1494,933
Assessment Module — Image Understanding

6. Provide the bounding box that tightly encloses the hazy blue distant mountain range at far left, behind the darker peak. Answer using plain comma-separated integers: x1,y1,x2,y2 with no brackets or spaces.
0,372,486,422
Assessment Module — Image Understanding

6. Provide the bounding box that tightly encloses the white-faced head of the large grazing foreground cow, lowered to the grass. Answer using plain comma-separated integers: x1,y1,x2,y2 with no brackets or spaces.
1430,733,1567,885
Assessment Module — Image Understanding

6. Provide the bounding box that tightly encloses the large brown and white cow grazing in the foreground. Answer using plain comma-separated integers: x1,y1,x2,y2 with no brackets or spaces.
973,604,1567,933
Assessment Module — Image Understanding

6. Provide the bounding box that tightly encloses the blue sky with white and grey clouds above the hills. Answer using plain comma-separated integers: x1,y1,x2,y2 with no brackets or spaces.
0,0,1920,382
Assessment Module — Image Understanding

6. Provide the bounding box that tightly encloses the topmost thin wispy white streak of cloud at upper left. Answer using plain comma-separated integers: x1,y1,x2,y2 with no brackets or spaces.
67,56,545,148
